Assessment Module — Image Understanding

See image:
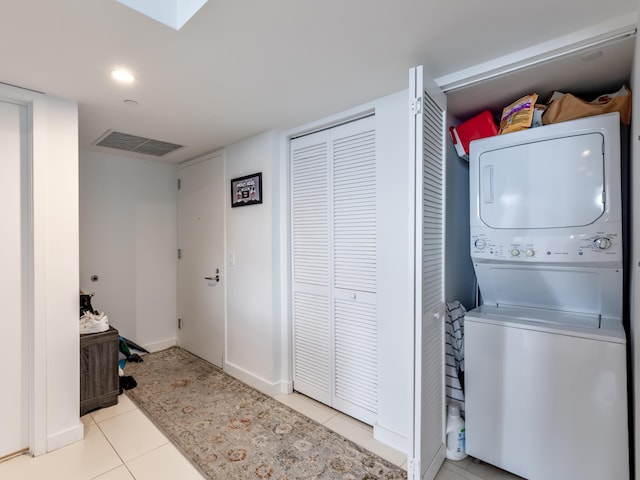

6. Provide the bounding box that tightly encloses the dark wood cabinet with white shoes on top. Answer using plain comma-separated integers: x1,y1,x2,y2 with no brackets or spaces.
80,327,120,415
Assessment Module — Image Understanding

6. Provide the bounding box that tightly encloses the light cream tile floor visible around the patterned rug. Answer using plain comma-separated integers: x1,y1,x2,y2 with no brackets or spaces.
0,393,519,480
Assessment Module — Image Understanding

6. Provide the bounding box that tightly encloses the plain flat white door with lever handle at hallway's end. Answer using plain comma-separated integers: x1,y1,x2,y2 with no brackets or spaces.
178,155,225,367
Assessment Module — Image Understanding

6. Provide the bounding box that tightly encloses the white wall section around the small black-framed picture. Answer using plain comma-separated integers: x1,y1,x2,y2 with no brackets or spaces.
224,132,281,394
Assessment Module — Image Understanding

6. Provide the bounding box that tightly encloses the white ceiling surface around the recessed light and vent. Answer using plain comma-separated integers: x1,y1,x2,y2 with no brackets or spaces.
0,0,638,162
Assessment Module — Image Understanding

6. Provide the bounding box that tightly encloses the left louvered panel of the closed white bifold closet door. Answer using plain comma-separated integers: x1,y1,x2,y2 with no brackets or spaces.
291,132,333,404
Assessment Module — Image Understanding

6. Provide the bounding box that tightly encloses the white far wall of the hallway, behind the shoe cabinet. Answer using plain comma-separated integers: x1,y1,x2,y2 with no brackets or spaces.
80,150,178,351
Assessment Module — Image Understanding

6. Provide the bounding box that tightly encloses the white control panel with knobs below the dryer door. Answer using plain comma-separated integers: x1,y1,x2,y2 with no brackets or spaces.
471,228,622,263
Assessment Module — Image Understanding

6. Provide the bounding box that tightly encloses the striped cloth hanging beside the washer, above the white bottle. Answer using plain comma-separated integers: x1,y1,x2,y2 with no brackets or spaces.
444,300,467,415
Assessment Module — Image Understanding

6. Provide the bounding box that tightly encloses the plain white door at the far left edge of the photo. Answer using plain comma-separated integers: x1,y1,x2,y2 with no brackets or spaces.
0,101,29,460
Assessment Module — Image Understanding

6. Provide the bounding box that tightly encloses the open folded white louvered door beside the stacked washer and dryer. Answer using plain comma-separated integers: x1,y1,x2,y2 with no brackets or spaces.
408,67,446,480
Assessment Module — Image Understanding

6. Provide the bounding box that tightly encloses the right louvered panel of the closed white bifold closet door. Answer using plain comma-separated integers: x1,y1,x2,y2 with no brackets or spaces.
332,117,378,423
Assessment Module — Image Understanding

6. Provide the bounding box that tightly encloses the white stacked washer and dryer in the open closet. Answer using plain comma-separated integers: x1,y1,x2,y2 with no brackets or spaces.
465,113,629,480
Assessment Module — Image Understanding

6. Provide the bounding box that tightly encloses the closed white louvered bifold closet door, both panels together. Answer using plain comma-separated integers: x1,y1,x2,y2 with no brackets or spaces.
291,116,378,424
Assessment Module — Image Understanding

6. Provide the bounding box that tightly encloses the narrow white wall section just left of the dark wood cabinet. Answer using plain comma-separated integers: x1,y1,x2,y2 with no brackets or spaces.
33,97,83,453
